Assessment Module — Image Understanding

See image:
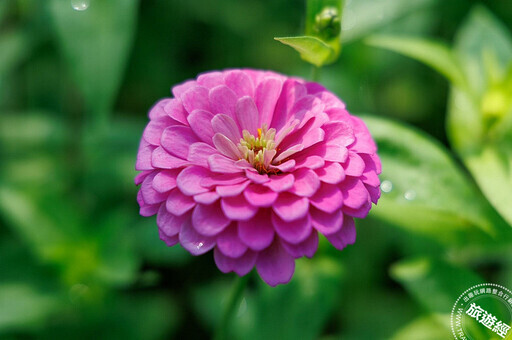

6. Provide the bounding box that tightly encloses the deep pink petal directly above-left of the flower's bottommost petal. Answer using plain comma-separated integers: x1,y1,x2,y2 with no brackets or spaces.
238,209,274,251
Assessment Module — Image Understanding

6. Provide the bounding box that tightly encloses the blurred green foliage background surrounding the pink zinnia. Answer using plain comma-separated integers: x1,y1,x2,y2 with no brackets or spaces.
0,0,512,339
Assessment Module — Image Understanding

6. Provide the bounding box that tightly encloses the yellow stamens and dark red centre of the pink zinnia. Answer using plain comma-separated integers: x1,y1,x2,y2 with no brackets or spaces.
237,124,279,174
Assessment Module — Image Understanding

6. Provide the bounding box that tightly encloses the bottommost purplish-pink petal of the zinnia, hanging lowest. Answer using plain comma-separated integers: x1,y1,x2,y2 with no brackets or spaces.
256,241,295,287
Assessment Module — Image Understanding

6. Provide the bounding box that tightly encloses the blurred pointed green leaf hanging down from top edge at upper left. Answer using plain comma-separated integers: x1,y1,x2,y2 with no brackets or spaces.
49,0,139,120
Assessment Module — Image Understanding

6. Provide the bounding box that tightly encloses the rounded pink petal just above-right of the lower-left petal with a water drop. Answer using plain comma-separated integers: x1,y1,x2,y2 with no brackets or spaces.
192,202,231,236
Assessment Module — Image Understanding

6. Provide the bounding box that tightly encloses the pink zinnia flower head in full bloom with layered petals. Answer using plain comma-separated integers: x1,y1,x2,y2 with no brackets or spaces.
135,70,381,286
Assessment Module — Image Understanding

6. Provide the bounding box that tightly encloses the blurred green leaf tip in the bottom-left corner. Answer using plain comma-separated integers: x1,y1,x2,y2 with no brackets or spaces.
0,282,59,334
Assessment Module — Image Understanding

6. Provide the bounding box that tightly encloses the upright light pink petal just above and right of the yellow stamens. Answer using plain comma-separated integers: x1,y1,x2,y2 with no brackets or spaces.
254,78,283,126
